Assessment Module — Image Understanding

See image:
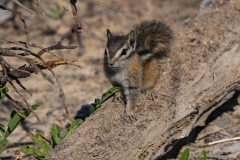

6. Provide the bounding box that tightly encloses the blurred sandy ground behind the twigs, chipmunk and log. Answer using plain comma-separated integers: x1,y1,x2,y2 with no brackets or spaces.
0,0,240,159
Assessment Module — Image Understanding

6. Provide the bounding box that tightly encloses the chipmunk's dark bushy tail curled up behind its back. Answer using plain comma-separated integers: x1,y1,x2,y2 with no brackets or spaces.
131,20,173,56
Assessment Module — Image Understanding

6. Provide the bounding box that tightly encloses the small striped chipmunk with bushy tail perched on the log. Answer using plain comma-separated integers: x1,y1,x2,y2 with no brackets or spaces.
104,20,173,120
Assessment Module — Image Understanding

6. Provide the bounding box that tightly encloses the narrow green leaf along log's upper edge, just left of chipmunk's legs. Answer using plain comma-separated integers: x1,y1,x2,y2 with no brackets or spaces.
89,87,122,115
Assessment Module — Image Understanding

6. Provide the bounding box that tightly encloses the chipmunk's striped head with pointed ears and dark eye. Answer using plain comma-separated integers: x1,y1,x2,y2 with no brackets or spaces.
104,29,134,69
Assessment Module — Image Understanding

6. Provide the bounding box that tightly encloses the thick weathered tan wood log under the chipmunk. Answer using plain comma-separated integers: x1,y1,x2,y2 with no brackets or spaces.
46,0,240,160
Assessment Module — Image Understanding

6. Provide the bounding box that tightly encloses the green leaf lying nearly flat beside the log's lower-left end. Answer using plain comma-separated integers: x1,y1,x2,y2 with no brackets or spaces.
20,146,47,159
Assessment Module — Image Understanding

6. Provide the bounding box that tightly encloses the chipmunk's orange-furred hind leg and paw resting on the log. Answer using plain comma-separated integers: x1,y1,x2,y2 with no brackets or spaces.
142,58,159,100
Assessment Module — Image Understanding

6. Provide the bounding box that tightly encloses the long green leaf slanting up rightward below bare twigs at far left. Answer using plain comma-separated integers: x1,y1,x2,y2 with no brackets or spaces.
4,104,39,139
